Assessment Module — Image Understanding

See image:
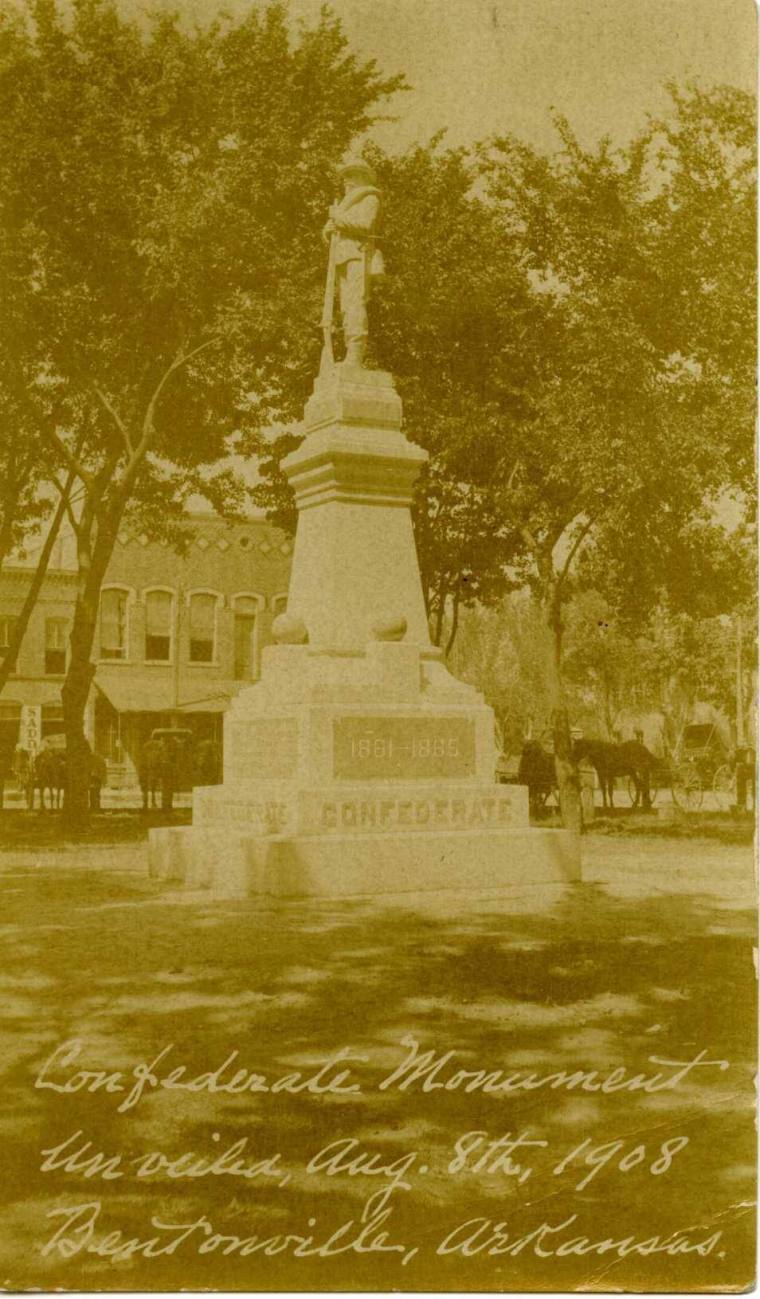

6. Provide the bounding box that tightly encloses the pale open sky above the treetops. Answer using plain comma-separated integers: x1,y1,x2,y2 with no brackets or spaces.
181,0,757,152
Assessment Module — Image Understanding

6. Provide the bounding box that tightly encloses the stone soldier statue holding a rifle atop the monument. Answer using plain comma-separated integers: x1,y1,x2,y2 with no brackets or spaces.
321,157,385,372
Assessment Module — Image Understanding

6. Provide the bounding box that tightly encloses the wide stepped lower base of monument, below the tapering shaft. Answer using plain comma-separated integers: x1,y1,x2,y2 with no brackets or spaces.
149,640,581,898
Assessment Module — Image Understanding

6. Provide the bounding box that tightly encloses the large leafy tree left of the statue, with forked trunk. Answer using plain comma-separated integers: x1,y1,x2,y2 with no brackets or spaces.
0,0,400,820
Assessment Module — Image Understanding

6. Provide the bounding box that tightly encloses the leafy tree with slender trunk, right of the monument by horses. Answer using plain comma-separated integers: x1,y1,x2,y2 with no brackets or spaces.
485,83,752,826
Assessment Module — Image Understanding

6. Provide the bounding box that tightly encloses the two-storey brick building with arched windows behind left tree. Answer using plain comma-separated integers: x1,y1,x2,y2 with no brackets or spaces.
0,514,292,785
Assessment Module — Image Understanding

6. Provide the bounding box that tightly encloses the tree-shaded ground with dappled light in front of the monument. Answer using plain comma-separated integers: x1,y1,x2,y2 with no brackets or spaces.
0,820,755,1290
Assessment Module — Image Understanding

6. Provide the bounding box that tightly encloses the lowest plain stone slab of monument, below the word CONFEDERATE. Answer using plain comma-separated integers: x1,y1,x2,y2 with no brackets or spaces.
151,826,581,899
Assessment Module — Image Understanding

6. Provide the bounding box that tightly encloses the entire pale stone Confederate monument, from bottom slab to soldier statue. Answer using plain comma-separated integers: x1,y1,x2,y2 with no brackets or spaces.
151,158,579,898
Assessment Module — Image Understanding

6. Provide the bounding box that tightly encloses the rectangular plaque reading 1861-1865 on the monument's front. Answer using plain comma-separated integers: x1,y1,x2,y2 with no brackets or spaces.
333,717,475,781
